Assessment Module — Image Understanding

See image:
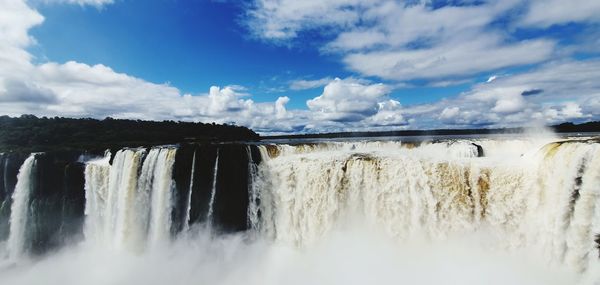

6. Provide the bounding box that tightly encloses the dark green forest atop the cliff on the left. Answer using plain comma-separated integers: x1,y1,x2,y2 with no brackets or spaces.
0,115,259,152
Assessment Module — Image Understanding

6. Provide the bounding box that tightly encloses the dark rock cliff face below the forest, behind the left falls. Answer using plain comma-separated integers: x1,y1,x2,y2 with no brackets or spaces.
0,143,260,254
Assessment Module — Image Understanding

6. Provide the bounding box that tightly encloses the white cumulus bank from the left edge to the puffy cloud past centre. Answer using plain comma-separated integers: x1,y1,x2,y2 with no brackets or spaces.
0,0,404,133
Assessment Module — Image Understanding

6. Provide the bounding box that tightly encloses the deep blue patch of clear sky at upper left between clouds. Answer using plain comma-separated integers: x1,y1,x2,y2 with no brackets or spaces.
31,0,343,97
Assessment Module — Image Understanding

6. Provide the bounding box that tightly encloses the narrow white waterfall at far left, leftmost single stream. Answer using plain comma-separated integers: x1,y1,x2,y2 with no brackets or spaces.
7,154,36,261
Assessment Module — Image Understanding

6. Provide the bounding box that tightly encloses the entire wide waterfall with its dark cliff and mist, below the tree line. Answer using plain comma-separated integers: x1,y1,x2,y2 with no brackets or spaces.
0,136,600,285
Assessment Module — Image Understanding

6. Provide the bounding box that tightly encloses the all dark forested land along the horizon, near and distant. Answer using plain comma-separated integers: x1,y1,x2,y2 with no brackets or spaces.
0,115,600,153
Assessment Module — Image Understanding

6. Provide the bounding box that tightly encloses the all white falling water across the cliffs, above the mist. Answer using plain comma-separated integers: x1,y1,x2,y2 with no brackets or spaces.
0,138,600,284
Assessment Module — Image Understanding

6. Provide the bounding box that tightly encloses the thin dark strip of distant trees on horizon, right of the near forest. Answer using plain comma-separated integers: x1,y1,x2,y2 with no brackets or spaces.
263,122,600,139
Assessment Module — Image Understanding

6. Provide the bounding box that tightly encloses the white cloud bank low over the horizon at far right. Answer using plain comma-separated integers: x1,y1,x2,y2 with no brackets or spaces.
402,60,600,128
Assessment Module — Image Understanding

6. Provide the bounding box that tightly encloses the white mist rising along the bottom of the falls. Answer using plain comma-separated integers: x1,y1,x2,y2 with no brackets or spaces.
0,224,578,285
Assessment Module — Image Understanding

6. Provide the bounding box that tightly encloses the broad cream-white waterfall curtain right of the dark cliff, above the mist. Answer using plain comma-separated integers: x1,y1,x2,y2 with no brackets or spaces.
255,141,600,272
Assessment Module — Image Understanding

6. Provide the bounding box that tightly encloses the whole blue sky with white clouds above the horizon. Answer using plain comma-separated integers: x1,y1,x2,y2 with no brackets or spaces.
0,0,600,134
